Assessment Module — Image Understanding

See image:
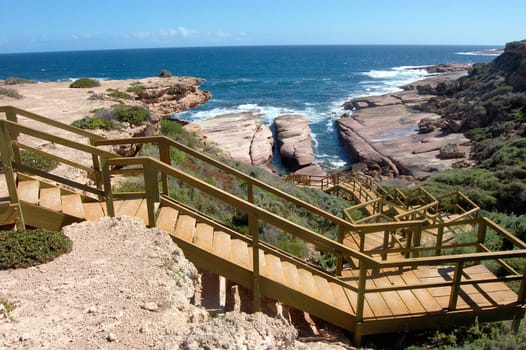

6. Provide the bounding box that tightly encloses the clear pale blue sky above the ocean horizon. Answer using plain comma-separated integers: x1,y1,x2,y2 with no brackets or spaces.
0,0,526,53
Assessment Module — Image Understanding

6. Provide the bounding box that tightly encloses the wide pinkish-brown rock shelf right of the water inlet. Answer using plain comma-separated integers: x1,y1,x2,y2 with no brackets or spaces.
336,64,471,179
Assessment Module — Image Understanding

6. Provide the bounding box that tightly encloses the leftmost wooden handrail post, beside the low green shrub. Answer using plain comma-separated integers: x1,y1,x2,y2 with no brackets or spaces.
0,123,26,230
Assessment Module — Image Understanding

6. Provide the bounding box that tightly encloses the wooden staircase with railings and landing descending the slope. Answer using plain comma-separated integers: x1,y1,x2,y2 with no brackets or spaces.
0,107,526,344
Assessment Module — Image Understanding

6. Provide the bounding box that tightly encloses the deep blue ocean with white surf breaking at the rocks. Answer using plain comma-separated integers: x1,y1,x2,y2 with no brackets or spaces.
0,45,495,173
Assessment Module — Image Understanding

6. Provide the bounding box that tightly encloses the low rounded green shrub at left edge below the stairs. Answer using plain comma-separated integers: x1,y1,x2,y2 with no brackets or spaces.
0,229,72,270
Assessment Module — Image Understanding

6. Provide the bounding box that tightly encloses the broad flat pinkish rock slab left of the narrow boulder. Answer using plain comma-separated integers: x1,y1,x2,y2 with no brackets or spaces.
185,113,274,166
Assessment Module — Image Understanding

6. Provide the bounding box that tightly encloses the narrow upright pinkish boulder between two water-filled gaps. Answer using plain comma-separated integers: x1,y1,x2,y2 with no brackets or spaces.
274,115,315,170
